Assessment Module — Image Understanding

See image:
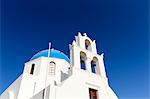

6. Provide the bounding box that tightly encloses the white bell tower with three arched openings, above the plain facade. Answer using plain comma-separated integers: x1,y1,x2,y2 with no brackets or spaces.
70,32,106,78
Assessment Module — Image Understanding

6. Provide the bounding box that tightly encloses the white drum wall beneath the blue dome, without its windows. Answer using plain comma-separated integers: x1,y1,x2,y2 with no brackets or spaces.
18,57,70,99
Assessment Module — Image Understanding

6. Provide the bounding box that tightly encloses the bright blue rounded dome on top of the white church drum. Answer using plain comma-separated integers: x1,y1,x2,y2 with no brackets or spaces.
30,49,70,63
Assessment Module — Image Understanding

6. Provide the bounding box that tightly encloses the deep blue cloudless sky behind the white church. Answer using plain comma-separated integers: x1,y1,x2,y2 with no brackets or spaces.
0,0,150,99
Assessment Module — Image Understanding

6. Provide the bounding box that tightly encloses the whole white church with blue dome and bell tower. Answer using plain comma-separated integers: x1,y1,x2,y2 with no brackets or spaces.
0,33,118,99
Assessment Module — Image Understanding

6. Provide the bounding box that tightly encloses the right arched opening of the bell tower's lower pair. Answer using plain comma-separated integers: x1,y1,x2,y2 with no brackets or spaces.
91,57,99,74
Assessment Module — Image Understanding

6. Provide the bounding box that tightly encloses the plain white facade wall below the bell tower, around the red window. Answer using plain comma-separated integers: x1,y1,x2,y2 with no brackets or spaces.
56,68,118,99
